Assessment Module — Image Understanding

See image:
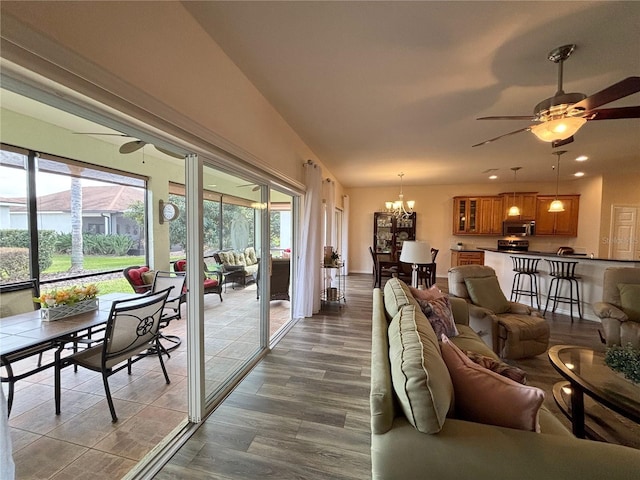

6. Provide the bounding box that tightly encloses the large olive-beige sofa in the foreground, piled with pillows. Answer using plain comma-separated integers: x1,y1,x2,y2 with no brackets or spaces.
370,279,640,480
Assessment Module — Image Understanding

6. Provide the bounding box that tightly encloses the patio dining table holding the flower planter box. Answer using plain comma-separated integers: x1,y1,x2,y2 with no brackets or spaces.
0,293,140,413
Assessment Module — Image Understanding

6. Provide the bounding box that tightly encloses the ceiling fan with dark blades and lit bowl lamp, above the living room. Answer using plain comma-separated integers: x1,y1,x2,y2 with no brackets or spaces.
473,44,640,148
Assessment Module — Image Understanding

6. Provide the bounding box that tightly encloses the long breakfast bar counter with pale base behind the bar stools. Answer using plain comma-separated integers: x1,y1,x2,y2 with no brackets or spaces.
478,247,640,322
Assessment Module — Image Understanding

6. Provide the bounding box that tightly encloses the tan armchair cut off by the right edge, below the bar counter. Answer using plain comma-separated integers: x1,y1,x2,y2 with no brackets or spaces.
592,267,640,348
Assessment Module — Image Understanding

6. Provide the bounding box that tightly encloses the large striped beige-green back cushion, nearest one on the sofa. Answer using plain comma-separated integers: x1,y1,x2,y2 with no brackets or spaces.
389,305,453,433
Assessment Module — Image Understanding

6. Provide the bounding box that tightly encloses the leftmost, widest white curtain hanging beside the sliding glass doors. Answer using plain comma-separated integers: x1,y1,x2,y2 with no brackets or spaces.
293,161,323,318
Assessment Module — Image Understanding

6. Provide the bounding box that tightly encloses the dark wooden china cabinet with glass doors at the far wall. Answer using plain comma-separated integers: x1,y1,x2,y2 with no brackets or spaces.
373,212,417,262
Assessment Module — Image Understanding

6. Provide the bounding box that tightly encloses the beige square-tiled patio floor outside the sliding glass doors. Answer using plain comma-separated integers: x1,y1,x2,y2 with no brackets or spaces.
5,285,290,479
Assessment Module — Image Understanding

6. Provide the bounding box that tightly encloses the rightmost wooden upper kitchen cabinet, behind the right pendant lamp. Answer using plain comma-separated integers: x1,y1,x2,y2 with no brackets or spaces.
536,195,580,237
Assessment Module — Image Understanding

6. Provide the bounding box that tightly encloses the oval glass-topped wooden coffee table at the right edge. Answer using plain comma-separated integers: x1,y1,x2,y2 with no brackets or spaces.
548,345,640,438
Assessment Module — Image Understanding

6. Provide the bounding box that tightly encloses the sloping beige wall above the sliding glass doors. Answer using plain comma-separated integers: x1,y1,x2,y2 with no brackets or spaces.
0,1,343,198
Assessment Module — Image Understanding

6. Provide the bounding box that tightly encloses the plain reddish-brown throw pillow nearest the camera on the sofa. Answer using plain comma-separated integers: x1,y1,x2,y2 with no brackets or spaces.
441,335,544,432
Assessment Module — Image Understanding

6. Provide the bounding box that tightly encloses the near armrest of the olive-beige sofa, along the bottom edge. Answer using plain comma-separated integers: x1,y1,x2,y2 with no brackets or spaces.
371,417,640,480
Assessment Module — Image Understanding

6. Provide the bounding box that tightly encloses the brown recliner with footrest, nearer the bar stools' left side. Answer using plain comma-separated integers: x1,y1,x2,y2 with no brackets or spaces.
449,265,550,359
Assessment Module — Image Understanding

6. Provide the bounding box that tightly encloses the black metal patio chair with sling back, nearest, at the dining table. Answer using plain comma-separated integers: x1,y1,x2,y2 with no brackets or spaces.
55,287,173,422
